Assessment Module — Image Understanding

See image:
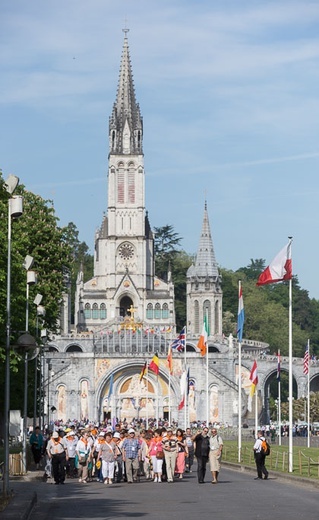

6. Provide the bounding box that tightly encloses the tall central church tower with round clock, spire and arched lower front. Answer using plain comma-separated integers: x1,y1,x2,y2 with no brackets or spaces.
75,29,175,330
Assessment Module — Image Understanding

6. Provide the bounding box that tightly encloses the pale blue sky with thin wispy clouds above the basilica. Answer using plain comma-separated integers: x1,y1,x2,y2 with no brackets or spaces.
0,0,319,299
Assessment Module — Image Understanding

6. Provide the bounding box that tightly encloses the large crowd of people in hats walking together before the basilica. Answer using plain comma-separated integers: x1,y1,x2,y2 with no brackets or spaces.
30,423,223,485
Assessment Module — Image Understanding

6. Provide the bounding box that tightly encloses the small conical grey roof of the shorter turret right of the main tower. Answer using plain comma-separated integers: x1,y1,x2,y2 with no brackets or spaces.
192,201,219,277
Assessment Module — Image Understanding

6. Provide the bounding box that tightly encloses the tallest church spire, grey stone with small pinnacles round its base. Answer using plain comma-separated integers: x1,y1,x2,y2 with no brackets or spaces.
109,29,143,154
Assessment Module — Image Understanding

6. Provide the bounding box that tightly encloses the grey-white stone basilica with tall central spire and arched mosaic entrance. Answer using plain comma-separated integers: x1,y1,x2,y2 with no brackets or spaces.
43,30,268,426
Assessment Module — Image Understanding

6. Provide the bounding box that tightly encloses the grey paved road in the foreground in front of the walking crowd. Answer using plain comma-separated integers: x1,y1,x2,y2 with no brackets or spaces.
14,468,319,520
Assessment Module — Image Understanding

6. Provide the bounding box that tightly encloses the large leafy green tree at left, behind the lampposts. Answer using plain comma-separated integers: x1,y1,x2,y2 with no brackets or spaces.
0,182,72,414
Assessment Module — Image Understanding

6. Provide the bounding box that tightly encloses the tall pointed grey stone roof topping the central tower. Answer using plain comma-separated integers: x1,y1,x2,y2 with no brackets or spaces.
110,29,143,153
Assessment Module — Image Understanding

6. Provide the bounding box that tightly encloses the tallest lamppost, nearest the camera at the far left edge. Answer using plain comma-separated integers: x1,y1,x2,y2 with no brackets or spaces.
3,175,23,497
